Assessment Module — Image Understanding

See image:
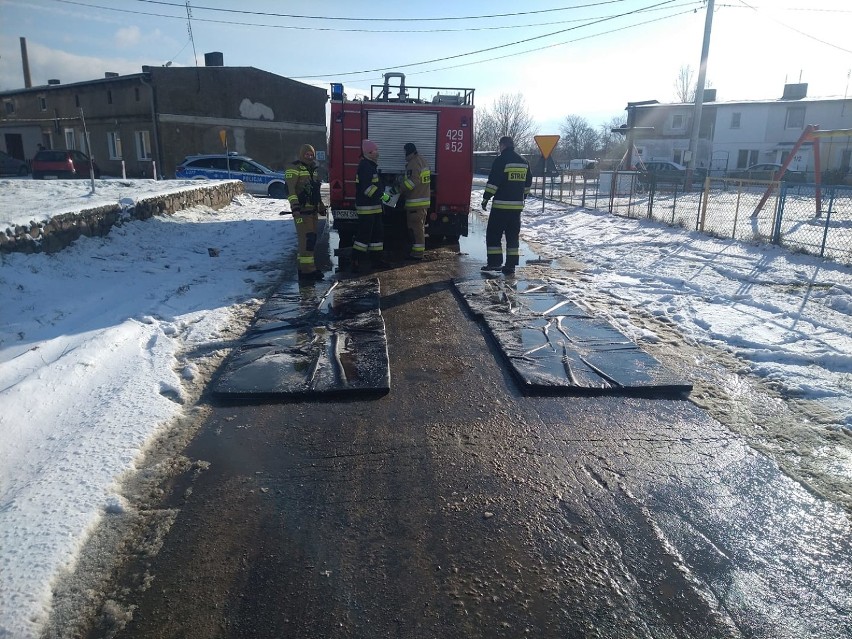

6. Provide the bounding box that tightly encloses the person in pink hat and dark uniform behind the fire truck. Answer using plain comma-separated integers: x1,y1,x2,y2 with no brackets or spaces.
352,140,391,273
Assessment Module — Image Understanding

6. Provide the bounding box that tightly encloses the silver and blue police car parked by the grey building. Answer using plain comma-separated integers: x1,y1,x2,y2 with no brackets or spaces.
175,153,287,199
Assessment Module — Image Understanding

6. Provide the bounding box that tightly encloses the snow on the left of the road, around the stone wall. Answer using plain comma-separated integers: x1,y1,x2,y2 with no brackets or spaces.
0,180,295,637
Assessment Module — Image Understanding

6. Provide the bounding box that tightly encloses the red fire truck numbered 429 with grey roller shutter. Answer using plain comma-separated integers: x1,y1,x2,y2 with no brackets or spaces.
328,73,473,249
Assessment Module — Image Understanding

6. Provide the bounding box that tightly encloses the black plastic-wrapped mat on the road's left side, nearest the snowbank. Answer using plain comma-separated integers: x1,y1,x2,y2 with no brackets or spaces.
213,279,390,398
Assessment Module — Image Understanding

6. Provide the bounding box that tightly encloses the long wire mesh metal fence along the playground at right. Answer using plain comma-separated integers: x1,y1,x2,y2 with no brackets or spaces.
533,171,852,265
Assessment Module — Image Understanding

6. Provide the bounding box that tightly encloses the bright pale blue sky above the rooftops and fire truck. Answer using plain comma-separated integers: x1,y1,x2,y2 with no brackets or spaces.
0,0,852,134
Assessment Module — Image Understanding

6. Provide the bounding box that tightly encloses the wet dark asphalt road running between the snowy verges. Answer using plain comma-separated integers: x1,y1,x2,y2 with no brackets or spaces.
81,214,852,639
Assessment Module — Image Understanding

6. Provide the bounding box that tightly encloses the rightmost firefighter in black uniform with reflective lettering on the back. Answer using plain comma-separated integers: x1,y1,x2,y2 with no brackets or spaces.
482,136,532,275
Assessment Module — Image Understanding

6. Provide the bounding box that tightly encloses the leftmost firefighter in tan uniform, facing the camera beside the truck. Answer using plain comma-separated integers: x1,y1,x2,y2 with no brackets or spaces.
284,144,325,280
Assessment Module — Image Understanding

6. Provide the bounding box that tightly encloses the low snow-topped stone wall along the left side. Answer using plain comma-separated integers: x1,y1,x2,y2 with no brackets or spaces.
0,181,245,253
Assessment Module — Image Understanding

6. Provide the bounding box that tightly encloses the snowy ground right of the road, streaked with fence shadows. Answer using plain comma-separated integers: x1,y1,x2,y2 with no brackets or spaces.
525,200,852,420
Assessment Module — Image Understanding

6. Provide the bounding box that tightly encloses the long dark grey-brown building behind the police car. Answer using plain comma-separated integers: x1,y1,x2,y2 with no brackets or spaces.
0,53,328,178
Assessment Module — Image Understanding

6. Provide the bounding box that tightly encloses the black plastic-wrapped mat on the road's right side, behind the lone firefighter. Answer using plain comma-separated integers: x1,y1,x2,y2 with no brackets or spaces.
453,278,692,395
